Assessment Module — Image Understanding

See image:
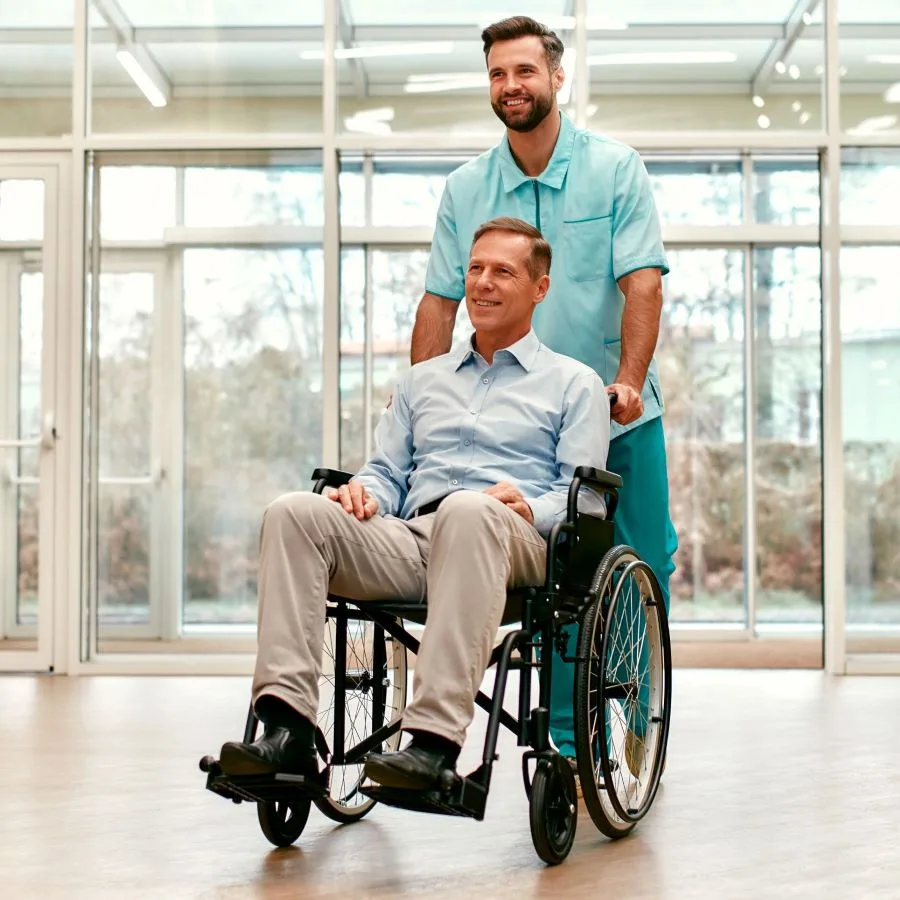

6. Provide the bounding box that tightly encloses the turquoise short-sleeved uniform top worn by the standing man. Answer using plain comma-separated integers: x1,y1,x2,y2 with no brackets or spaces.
425,115,669,437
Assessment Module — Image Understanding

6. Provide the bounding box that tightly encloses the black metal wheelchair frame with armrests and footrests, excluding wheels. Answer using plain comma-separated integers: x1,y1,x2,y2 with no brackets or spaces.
200,467,668,862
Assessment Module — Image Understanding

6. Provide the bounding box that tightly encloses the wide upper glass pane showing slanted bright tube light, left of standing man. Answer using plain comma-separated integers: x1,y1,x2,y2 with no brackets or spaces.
90,0,324,134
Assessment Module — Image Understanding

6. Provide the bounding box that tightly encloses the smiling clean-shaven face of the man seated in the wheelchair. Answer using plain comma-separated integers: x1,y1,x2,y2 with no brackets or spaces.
466,231,550,349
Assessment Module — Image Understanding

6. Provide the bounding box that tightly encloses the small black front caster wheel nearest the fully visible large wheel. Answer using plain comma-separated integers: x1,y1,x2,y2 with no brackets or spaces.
528,760,578,866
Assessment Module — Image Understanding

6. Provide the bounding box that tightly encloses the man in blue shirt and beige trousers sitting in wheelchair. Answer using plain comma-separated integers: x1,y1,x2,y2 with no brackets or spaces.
219,218,609,790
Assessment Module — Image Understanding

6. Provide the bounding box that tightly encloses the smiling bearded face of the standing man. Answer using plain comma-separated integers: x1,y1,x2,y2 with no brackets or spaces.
487,36,565,132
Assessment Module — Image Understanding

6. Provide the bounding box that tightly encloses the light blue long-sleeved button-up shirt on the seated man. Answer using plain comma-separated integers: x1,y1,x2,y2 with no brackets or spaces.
354,331,610,537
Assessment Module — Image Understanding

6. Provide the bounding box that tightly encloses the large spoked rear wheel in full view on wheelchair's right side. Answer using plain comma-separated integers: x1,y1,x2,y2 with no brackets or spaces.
575,545,672,839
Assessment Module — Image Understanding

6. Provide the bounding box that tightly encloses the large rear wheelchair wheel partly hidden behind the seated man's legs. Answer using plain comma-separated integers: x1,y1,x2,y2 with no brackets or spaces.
314,616,407,823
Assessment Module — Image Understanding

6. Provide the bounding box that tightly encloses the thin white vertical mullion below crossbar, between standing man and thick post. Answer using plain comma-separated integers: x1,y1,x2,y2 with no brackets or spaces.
744,246,759,639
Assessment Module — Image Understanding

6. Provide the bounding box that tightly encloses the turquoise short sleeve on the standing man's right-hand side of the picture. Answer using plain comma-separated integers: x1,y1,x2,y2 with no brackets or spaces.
612,151,669,281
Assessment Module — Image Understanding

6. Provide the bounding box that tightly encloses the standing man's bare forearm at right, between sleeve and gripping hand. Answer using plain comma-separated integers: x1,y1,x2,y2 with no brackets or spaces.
616,269,662,391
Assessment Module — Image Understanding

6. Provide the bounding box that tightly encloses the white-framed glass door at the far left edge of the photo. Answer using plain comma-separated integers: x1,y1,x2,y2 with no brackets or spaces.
0,169,58,671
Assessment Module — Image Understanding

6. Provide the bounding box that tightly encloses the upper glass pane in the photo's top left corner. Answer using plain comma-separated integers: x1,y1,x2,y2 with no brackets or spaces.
0,0,74,139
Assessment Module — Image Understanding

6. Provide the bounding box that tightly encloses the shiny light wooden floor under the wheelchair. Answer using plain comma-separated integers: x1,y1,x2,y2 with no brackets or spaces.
0,670,900,900
